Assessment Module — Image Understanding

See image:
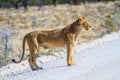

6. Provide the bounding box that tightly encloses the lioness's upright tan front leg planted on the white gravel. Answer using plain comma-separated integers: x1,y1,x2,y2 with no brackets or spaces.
66,34,75,66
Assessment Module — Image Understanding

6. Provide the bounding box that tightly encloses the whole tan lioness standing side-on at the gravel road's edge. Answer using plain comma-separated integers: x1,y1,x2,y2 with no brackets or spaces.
12,16,91,70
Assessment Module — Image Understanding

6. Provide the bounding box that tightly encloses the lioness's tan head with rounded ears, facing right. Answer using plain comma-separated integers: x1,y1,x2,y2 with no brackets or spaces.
78,16,91,30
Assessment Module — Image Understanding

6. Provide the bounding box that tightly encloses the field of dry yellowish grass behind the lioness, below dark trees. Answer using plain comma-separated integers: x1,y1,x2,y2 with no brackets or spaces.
0,2,120,67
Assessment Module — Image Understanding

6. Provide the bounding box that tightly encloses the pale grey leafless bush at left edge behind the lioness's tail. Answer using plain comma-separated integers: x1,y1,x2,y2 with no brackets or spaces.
0,28,14,67
